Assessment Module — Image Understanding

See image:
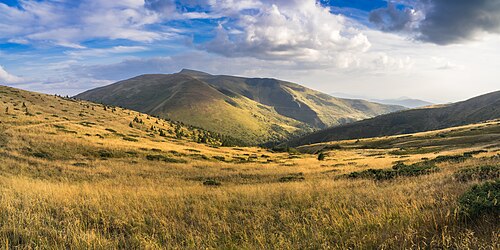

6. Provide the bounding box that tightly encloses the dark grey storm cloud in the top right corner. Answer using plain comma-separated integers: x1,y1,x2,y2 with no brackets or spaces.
370,0,500,45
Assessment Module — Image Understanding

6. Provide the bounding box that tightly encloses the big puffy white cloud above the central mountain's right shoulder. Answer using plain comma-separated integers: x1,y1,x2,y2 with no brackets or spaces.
202,0,371,63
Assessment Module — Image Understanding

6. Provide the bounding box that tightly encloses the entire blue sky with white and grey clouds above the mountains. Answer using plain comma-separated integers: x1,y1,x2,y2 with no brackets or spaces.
0,0,500,103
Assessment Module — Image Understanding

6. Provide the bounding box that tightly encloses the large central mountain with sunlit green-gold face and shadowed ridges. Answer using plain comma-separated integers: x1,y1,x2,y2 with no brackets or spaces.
76,69,403,143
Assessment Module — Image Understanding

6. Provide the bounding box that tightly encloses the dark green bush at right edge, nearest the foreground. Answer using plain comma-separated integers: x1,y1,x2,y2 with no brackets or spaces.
458,180,500,219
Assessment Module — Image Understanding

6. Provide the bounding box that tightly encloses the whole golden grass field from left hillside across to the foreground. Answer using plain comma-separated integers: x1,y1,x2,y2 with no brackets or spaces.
0,87,500,249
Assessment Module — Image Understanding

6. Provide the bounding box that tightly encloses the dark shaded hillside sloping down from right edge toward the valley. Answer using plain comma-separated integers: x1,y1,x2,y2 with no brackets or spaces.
287,91,500,146
